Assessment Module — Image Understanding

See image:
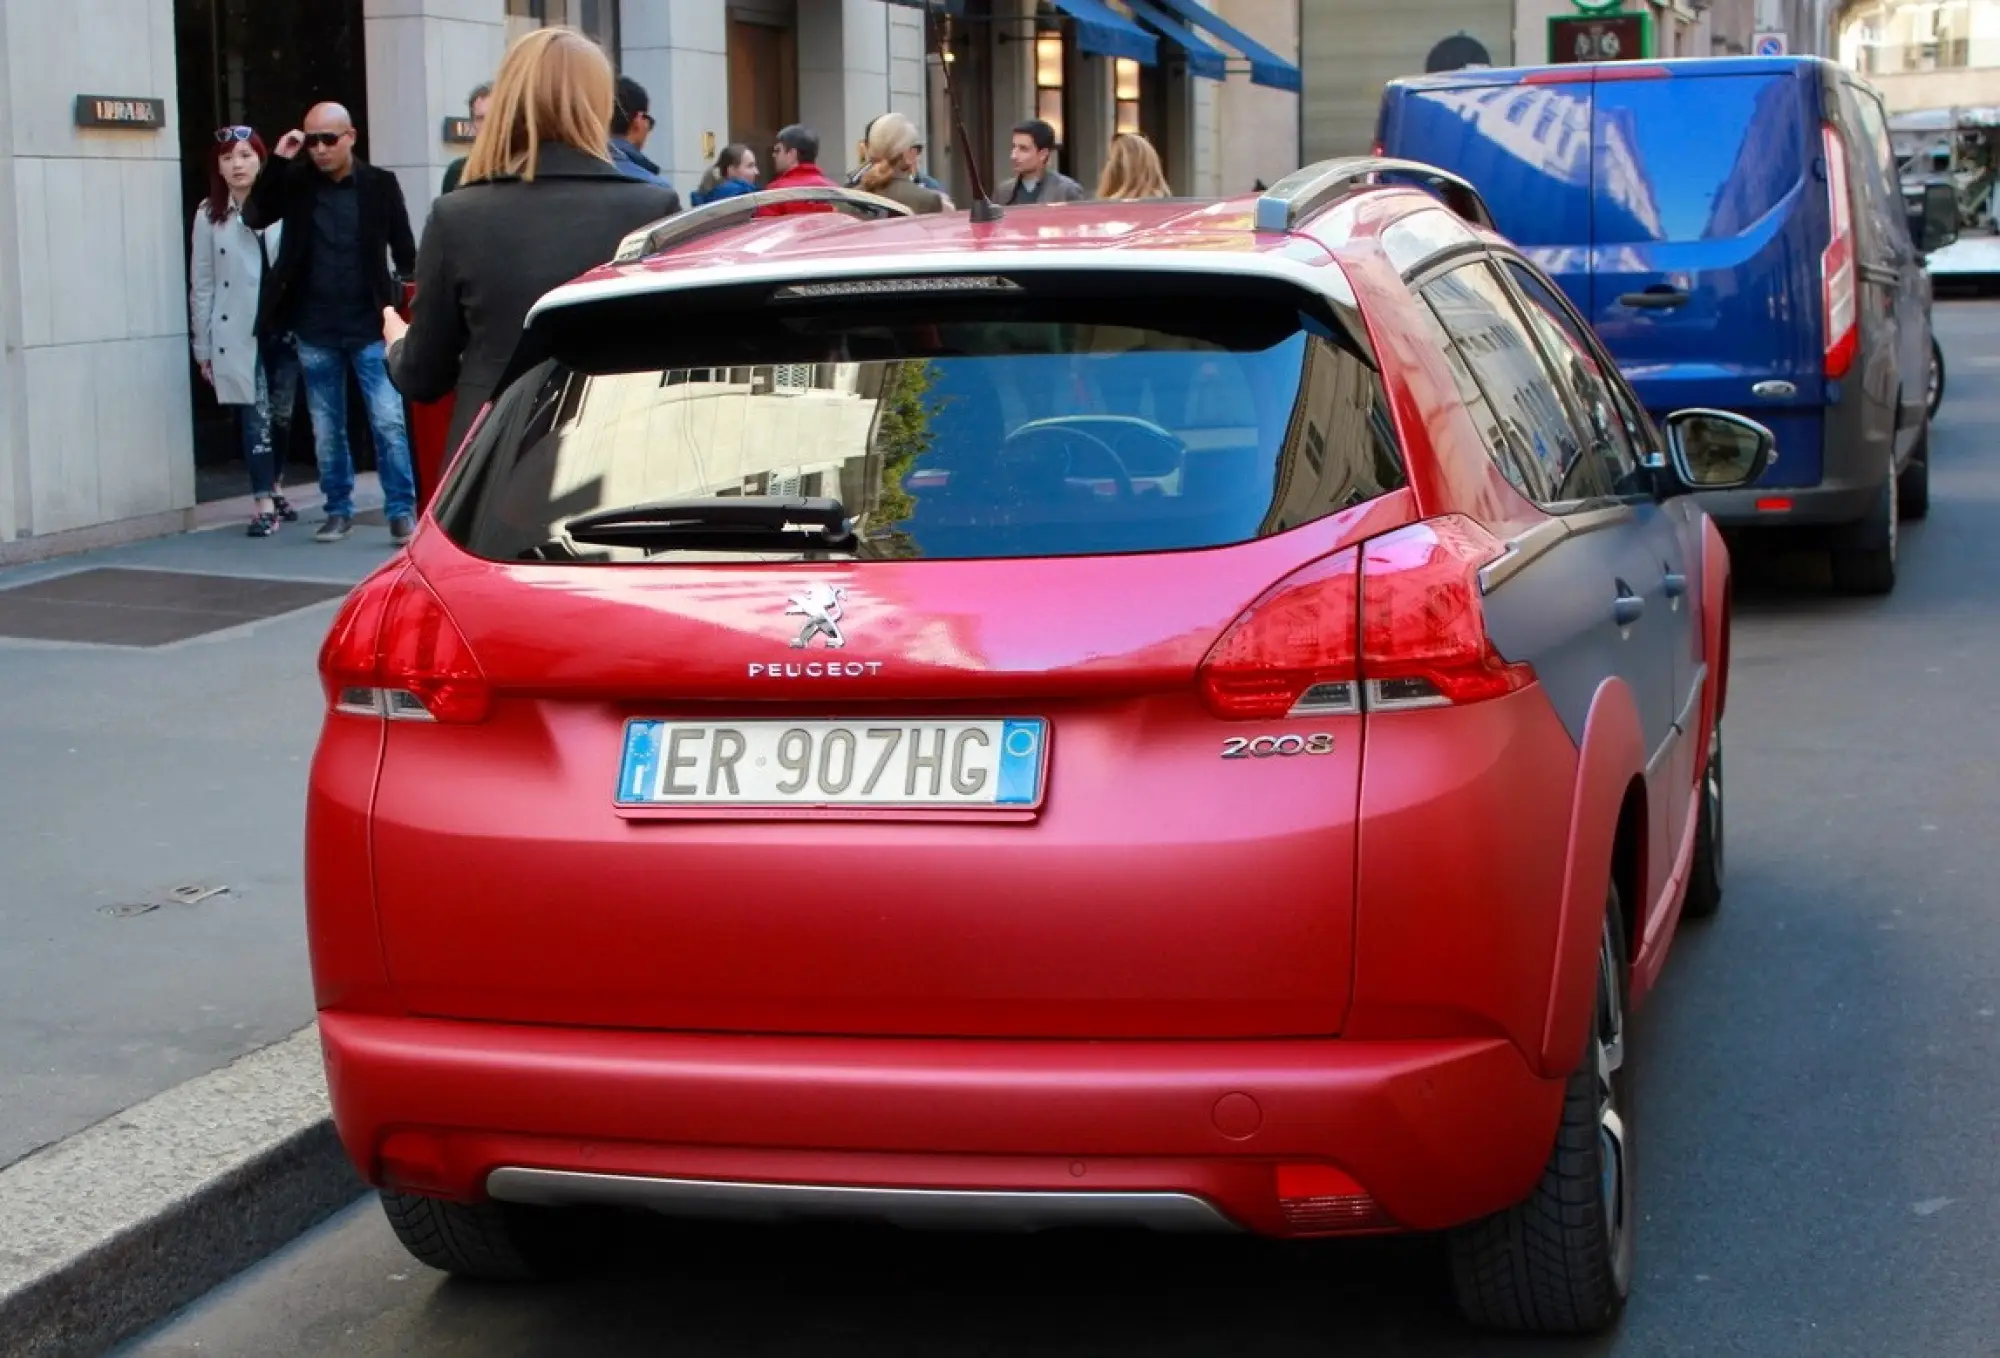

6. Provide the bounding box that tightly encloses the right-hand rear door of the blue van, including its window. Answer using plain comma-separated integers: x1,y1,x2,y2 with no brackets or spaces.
1572,62,1830,486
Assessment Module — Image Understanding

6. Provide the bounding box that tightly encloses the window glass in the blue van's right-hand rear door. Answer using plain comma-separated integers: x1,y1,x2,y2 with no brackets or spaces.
1594,74,1818,246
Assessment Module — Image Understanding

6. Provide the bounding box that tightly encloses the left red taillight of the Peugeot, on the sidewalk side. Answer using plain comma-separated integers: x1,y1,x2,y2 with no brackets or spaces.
320,566,492,726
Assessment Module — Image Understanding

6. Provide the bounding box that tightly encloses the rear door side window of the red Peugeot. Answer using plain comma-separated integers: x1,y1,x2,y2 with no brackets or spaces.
1422,262,1610,514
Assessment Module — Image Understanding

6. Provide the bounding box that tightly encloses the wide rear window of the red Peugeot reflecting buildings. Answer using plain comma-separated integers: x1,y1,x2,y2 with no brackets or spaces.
438,278,1404,564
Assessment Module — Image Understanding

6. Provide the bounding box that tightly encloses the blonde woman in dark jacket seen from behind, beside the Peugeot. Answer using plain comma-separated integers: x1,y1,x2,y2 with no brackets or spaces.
378,26,680,462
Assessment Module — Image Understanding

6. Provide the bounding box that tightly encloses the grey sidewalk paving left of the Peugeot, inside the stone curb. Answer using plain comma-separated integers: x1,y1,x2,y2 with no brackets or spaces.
0,478,394,1166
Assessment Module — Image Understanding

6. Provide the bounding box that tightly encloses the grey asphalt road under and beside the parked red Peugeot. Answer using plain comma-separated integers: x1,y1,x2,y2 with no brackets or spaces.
117,304,2000,1358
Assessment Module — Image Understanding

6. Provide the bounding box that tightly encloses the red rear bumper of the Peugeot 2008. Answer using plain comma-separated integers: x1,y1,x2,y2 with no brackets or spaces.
320,1010,1562,1234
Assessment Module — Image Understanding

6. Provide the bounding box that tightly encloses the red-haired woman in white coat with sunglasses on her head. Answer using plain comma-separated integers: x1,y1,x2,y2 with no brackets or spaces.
188,126,298,538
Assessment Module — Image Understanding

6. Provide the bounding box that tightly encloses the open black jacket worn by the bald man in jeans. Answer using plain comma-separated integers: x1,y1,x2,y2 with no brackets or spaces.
244,152,416,334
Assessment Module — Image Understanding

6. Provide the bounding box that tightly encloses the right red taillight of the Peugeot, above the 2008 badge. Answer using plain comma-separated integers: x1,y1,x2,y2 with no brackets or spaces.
1200,514,1534,720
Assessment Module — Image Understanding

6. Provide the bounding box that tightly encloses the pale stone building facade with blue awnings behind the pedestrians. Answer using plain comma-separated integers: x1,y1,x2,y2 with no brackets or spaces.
0,0,1300,560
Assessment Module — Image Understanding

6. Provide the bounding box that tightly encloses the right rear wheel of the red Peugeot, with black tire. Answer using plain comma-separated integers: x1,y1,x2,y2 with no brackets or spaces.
1450,888,1638,1334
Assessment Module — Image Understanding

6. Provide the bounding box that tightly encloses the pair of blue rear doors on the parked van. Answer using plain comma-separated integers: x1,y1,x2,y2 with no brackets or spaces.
1382,60,1828,486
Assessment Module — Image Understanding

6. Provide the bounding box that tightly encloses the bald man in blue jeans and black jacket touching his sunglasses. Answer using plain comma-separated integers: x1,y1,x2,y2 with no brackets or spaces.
244,104,416,544
